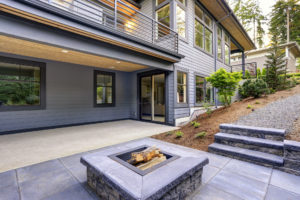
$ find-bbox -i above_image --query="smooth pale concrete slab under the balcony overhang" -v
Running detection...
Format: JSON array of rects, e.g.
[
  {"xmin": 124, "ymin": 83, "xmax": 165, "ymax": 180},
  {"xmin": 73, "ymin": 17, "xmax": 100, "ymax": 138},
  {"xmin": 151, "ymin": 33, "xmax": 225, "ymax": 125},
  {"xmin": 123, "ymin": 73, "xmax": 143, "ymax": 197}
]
[{"xmin": 0, "ymin": 120, "xmax": 176, "ymax": 173}]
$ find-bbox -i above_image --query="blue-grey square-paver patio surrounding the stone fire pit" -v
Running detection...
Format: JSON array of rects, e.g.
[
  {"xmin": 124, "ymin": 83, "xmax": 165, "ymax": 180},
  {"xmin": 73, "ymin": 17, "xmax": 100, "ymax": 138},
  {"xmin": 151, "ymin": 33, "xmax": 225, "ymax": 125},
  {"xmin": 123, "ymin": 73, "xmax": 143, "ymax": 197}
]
[{"xmin": 0, "ymin": 138, "xmax": 300, "ymax": 200}]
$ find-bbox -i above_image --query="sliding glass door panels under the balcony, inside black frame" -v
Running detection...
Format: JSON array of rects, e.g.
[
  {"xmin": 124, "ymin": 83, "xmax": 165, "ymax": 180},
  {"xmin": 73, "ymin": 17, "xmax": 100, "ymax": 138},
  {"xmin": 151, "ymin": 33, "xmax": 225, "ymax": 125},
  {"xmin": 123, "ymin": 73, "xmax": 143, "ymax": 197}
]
[{"xmin": 140, "ymin": 74, "xmax": 165, "ymax": 123}]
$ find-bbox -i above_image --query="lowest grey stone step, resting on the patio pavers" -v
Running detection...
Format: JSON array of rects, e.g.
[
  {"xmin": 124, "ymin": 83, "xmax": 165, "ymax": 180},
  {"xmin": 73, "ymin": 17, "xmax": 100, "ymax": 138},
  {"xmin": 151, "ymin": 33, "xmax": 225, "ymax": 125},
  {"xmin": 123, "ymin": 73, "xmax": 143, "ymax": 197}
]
[{"xmin": 208, "ymin": 143, "xmax": 283, "ymax": 167}]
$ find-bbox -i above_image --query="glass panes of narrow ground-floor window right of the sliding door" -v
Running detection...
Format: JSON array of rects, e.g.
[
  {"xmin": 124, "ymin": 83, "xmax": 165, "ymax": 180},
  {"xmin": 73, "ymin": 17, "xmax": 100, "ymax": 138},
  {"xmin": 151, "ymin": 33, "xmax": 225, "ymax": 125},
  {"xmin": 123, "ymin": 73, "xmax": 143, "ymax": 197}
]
[{"xmin": 177, "ymin": 71, "xmax": 187, "ymax": 103}]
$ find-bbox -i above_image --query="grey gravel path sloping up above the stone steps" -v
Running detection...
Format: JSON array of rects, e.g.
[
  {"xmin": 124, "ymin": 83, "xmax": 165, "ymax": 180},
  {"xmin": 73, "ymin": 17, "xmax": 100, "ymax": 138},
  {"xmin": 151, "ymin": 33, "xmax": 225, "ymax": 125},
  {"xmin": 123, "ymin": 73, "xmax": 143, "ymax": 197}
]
[{"xmin": 235, "ymin": 94, "xmax": 300, "ymax": 132}]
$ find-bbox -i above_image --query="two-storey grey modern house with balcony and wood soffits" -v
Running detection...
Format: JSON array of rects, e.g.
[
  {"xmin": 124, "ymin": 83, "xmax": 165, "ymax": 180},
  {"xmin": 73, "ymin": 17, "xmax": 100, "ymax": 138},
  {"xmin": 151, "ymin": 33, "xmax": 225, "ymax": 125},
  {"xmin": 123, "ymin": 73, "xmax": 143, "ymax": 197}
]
[{"xmin": 0, "ymin": 0, "xmax": 255, "ymax": 134}]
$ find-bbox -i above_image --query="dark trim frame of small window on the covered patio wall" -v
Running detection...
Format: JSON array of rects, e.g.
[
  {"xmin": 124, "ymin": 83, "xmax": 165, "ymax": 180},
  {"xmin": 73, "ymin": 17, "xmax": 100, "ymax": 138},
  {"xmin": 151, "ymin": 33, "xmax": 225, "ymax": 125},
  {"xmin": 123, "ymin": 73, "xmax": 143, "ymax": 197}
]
[{"xmin": 93, "ymin": 70, "xmax": 116, "ymax": 107}]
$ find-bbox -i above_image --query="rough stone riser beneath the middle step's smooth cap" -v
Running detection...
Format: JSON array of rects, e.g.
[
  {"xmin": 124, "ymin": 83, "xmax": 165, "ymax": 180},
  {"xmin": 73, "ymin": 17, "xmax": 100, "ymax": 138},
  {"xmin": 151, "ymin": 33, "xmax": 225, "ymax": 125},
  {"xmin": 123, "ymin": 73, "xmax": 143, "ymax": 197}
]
[{"xmin": 215, "ymin": 138, "xmax": 283, "ymax": 156}]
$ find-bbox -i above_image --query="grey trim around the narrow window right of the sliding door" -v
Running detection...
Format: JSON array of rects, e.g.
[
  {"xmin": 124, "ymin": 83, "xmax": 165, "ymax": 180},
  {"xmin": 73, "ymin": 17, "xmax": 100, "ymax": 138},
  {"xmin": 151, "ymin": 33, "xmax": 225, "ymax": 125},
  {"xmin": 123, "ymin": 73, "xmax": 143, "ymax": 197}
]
[{"xmin": 174, "ymin": 67, "xmax": 189, "ymax": 108}]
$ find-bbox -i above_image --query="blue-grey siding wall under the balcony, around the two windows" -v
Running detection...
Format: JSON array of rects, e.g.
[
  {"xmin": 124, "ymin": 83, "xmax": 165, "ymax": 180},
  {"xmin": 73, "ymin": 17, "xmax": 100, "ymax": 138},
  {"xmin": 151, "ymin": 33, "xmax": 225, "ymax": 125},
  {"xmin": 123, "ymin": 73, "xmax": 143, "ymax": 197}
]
[{"xmin": 0, "ymin": 54, "xmax": 136, "ymax": 132}]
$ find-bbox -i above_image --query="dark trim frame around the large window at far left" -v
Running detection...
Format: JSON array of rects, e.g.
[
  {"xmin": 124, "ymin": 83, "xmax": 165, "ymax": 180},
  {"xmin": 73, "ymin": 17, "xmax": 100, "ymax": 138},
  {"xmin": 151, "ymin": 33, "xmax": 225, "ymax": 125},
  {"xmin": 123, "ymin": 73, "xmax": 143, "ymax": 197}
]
[{"xmin": 0, "ymin": 56, "xmax": 46, "ymax": 112}]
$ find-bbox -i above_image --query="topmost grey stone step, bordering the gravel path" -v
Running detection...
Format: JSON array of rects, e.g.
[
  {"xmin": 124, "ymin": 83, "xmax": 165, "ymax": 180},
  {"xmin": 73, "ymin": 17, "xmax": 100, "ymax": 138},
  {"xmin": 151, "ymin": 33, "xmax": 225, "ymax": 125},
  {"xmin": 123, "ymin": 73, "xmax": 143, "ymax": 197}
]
[{"xmin": 220, "ymin": 124, "xmax": 285, "ymax": 142}]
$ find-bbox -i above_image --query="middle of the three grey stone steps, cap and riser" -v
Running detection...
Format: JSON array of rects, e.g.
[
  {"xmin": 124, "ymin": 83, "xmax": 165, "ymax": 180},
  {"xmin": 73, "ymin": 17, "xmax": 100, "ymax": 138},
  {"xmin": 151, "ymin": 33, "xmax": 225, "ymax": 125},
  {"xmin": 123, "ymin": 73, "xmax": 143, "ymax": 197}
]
[{"xmin": 215, "ymin": 133, "xmax": 284, "ymax": 156}]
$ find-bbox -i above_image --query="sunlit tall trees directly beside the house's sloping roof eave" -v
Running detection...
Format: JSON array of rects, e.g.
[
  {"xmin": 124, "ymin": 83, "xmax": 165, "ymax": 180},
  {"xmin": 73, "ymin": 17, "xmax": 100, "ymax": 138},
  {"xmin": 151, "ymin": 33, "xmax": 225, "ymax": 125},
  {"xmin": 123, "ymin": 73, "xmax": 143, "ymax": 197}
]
[{"xmin": 229, "ymin": 0, "xmax": 266, "ymax": 47}]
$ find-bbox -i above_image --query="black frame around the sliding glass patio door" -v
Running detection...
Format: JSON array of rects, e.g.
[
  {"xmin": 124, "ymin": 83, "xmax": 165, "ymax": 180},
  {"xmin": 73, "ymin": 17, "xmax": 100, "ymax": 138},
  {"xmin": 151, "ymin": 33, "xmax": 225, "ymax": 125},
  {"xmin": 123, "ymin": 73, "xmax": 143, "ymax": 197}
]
[{"xmin": 137, "ymin": 70, "xmax": 168, "ymax": 124}]
